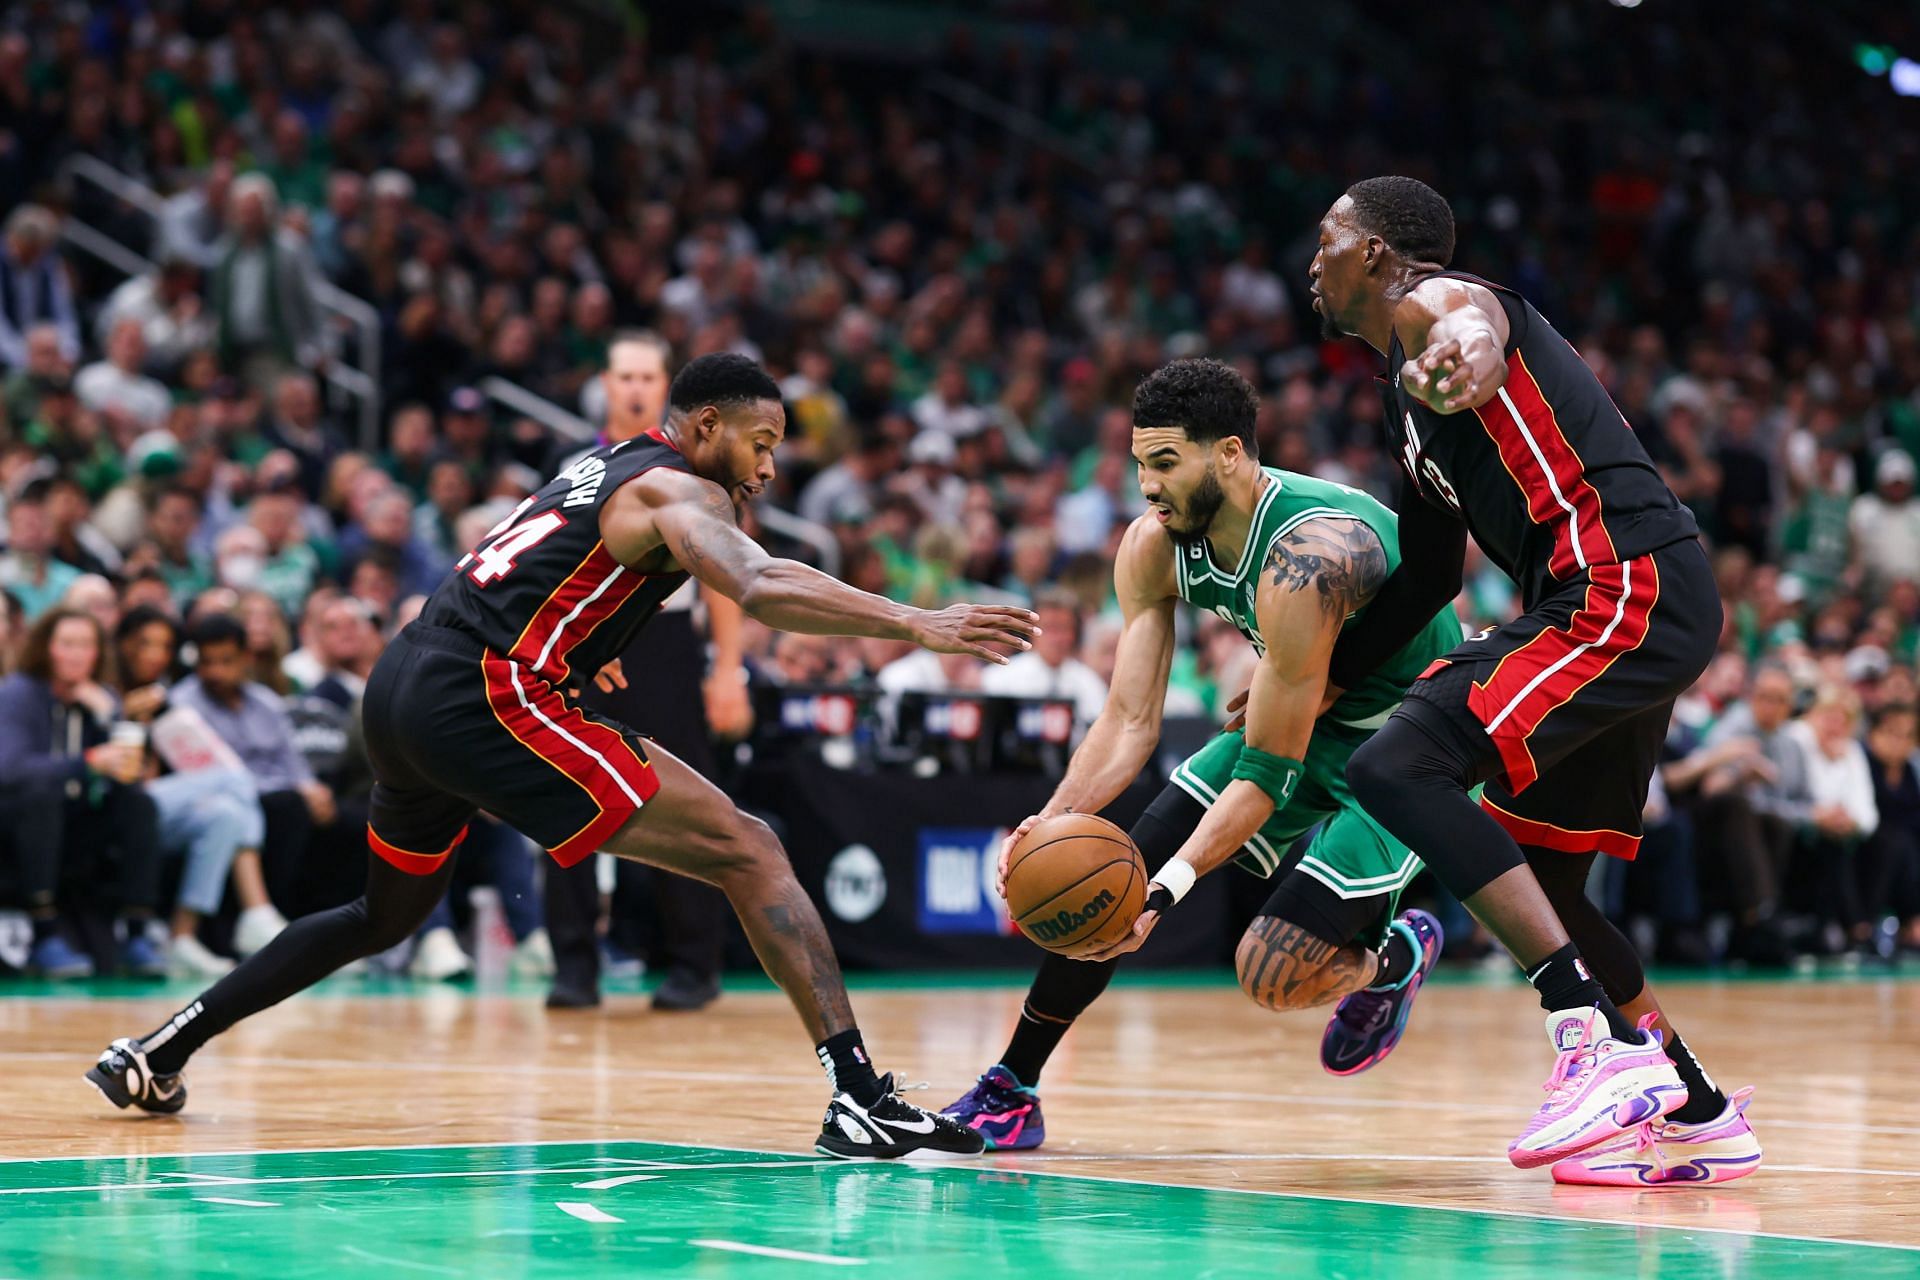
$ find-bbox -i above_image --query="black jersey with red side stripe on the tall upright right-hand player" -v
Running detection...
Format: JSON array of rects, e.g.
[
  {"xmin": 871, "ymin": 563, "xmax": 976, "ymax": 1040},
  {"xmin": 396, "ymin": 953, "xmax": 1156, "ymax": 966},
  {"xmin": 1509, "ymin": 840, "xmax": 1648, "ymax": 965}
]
[{"xmin": 1386, "ymin": 271, "xmax": 1699, "ymax": 608}]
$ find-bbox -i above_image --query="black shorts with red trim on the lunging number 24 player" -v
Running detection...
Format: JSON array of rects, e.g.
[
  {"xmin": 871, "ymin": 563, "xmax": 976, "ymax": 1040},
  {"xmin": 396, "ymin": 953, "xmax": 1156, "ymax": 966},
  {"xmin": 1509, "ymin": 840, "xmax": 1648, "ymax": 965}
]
[{"xmin": 363, "ymin": 624, "xmax": 660, "ymax": 875}]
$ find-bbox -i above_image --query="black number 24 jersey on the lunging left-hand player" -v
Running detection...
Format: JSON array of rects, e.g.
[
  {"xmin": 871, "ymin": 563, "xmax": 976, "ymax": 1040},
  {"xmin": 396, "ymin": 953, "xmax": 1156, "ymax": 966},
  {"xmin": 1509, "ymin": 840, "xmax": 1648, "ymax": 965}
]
[{"xmin": 420, "ymin": 432, "xmax": 691, "ymax": 685}]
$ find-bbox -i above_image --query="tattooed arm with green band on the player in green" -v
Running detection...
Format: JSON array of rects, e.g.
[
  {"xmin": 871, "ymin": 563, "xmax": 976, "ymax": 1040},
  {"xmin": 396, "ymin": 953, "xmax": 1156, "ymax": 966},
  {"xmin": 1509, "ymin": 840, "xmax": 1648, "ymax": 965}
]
[{"xmin": 1087, "ymin": 516, "xmax": 1386, "ymax": 960}]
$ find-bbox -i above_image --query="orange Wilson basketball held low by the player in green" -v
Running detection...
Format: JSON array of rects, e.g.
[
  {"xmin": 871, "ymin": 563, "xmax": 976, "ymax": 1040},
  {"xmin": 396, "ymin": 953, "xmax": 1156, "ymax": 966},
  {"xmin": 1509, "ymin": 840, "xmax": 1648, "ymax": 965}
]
[{"xmin": 1006, "ymin": 814, "xmax": 1146, "ymax": 956}]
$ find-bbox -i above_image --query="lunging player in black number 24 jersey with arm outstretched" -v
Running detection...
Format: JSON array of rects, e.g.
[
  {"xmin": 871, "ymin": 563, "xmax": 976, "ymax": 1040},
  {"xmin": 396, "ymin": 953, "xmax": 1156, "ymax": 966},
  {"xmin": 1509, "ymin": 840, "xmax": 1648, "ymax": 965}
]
[{"xmin": 86, "ymin": 355, "xmax": 1037, "ymax": 1157}]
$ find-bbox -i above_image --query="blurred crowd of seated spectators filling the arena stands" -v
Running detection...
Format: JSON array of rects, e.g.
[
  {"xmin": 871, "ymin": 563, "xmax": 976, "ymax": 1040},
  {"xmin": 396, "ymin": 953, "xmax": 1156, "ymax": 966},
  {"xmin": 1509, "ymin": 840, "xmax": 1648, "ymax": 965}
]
[{"xmin": 0, "ymin": 0, "xmax": 1920, "ymax": 971}]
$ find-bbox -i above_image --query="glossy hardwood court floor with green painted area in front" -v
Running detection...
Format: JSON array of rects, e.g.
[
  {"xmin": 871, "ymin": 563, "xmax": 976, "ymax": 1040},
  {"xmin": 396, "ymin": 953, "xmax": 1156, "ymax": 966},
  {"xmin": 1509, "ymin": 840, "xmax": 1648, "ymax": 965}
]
[{"xmin": 0, "ymin": 979, "xmax": 1920, "ymax": 1280}]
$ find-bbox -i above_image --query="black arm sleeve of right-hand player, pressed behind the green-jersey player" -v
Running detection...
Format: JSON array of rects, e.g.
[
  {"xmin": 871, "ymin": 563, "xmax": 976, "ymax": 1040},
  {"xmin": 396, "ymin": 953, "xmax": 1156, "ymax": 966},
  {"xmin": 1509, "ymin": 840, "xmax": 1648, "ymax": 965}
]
[{"xmin": 1327, "ymin": 474, "xmax": 1467, "ymax": 689}]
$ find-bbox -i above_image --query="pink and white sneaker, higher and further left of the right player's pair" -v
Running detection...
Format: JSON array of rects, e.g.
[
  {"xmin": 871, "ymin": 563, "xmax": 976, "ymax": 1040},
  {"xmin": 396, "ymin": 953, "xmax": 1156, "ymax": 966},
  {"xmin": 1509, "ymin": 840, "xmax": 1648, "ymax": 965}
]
[{"xmin": 1507, "ymin": 1007, "xmax": 1686, "ymax": 1169}]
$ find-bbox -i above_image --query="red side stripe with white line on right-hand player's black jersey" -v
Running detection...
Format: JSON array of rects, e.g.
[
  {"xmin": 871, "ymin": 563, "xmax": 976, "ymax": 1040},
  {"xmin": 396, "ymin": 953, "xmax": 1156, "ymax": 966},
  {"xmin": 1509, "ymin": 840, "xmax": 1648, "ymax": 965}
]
[{"xmin": 1475, "ymin": 351, "xmax": 1619, "ymax": 578}]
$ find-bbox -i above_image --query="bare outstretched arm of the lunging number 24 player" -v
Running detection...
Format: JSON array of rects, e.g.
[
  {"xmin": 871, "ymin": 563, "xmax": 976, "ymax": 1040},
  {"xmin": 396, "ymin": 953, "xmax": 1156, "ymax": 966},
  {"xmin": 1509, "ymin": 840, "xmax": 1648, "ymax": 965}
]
[{"xmin": 601, "ymin": 468, "xmax": 1037, "ymax": 662}]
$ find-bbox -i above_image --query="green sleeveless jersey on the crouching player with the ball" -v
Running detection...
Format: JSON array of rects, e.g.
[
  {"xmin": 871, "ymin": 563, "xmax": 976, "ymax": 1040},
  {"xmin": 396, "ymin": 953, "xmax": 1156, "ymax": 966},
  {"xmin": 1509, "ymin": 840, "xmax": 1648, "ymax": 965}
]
[{"xmin": 1175, "ymin": 466, "xmax": 1459, "ymax": 729}]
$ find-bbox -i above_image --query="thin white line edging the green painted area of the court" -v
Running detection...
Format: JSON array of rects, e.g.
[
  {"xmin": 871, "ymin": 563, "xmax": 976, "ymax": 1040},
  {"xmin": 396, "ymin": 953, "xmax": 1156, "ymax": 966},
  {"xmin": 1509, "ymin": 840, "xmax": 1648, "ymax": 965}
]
[{"xmin": 6, "ymin": 1138, "xmax": 1920, "ymax": 1253}]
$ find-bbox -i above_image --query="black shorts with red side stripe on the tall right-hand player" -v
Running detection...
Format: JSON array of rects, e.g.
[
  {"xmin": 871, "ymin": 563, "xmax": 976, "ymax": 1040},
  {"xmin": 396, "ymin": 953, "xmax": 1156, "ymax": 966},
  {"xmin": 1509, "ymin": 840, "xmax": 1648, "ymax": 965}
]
[{"xmin": 1407, "ymin": 539, "xmax": 1720, "ymax": 858}]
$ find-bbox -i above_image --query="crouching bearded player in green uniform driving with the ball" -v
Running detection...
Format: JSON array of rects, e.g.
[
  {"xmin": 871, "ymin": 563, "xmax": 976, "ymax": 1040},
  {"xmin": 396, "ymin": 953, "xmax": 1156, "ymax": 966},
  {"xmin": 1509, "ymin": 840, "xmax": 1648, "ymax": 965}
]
[{"xmin": 947, "ymin": 359, "xmax": 1459, "ymax": 1150}]
